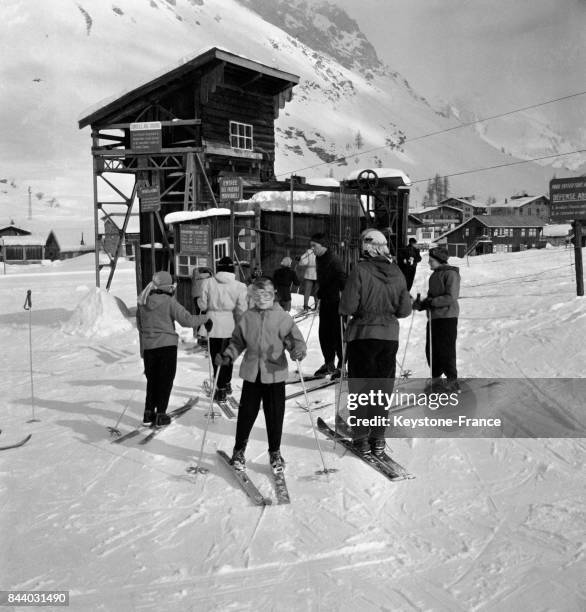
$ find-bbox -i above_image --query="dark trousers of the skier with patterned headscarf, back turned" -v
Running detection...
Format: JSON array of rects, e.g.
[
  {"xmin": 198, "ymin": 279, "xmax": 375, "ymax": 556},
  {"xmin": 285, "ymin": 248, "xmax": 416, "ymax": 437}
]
[{"xmin": 347, "ymin": 339, "xmax": 399, "ymax": 439}]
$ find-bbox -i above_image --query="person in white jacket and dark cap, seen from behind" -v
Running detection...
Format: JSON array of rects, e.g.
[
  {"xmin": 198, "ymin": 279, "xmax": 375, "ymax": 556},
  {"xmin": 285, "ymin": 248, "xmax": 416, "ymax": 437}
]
[{"xmin": 197, "ymin": 257, "xmax": 248, "ymax": 401}]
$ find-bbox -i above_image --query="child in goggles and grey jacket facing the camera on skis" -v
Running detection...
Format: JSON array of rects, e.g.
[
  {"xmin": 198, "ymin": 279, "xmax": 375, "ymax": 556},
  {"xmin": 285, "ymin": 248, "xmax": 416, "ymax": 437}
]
[{"xmin": 216, "ymin": 277, "xmax": 306, "ymax": 470}]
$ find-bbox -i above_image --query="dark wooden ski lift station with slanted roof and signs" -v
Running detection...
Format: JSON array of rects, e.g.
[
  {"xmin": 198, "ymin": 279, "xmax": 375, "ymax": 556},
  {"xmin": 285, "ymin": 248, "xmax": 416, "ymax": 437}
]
[{"xmin": 79, "ymin": 47, "xmax": 408, "ymax": 309}]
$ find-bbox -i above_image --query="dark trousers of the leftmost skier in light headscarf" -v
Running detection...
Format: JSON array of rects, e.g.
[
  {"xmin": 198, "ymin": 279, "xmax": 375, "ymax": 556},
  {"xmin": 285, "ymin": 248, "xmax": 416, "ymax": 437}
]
[{"xmin": 143, "ymin": 346, "xmax": 177, "ymax": 413}]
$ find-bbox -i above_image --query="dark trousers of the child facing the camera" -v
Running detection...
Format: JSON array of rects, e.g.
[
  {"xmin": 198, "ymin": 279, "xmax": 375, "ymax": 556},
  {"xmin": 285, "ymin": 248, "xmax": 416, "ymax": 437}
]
[{"xmin": 234, "ymin": 374, "xmax": 285, "ymax": 452}]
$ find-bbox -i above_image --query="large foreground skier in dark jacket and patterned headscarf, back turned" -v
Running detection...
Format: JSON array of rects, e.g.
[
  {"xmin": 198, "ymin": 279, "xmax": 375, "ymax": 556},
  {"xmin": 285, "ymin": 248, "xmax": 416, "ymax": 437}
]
[{"xmin": 340, "ymin": 229, "xmax": 411, "ymax": 456}]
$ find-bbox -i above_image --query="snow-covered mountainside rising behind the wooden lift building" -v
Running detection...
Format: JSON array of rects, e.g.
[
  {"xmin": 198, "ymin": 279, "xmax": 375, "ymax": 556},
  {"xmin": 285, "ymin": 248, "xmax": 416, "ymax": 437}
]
[{"xmin": 0, "ymin": 0, "xmax": 580, "ymax": 228}]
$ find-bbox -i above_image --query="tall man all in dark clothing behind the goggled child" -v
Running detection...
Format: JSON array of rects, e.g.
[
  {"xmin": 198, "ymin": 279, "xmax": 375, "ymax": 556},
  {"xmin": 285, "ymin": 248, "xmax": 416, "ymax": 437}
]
[{"xmin": 310, "ymin": 233, "xmax": 346, "ymax": 378}]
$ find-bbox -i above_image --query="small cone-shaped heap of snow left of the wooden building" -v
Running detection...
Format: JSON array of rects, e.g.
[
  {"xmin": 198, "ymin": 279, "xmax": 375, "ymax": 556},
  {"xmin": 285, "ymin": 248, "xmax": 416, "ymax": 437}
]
[{"xmin": 63, "ymin": 288, "xmax": 132, "ymax": 338}]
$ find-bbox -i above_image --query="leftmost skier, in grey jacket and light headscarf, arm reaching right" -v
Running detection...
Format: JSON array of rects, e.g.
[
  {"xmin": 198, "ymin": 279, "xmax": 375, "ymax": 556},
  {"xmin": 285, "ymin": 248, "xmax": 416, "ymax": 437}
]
[{"xmin": 136, "ymin": 270, "xmax": 213, "ymax": 426}]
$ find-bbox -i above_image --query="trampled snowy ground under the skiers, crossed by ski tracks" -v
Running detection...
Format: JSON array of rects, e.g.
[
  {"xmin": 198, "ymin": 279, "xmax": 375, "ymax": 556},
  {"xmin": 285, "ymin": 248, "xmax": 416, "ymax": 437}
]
[{"xmin": 0, "ymin": 249, "xmax": 586, "ymax": 611}]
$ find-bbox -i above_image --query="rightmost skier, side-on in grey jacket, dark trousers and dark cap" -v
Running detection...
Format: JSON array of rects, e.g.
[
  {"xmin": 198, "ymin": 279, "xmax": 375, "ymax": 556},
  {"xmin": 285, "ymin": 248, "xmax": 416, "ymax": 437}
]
[{"xmin": 413, "ymin": 247, "xmax": 460, "ymax": 391}]
